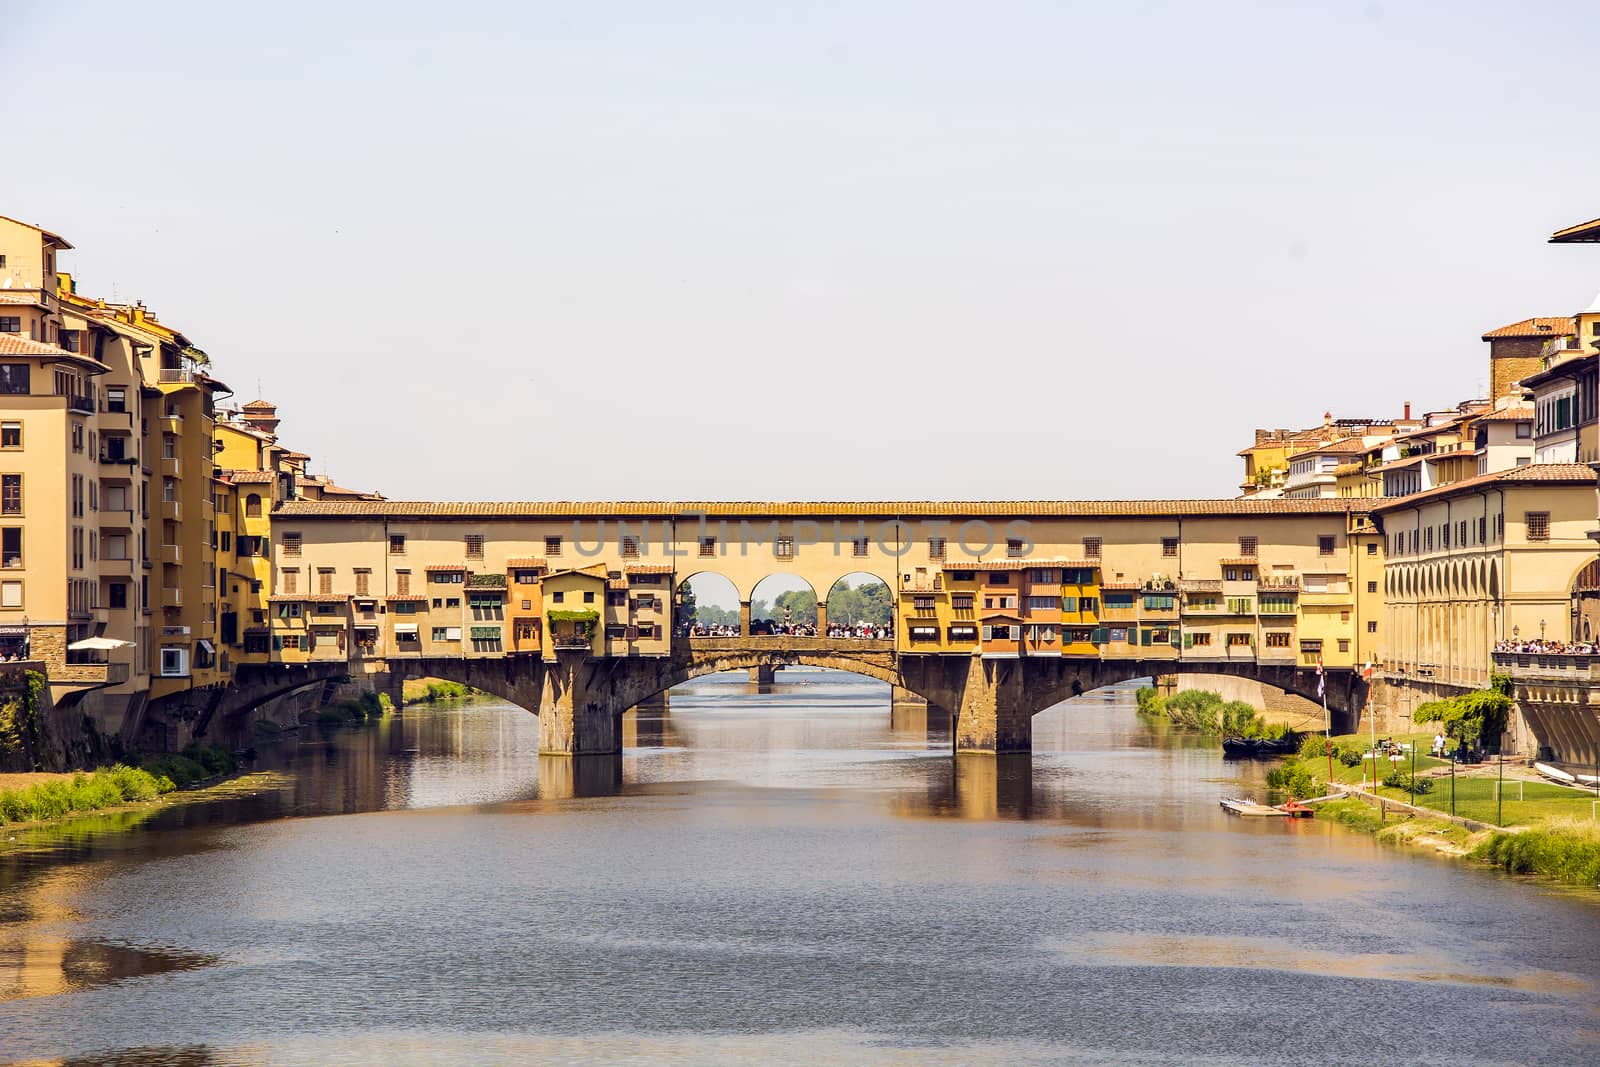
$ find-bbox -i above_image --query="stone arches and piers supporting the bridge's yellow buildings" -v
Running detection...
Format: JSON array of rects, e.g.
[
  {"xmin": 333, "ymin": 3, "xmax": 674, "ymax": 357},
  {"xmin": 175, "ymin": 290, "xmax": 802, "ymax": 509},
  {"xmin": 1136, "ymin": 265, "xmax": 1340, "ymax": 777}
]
[{"xmin": 377, "ymin": 637, "xmax": 1368, "ymax": 755}]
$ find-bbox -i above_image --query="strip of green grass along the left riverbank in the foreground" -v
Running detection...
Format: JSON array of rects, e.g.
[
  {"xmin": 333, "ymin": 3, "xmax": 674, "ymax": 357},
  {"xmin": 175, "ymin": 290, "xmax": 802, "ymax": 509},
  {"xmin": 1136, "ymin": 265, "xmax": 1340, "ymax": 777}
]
[{"xmin": 0, "ymin": 745, "xmax": 238, "ymax": 825}]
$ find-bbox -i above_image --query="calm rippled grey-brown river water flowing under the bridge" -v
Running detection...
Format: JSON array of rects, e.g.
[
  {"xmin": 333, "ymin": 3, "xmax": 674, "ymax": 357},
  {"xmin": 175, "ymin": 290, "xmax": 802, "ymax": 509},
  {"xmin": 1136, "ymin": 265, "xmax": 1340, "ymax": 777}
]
[{"xmin": 0, "ymin": 672, "xmax": 1600, "ymax": 1065}]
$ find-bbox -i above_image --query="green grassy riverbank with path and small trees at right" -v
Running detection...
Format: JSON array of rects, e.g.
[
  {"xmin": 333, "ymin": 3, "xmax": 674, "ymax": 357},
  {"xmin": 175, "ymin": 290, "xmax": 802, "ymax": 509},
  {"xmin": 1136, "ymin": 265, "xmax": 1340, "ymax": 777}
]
[{"xmin": 1269, "ymin": 734, "xmax": 1600, "ymax": 888}]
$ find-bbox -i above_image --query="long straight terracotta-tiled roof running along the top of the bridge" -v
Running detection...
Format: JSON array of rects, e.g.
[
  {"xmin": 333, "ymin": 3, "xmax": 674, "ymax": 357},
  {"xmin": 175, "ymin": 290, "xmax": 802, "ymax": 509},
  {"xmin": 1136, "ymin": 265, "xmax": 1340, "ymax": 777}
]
[{"xmin": 277, "ymin": 498, "xmax": 1368, "ymax": 523}]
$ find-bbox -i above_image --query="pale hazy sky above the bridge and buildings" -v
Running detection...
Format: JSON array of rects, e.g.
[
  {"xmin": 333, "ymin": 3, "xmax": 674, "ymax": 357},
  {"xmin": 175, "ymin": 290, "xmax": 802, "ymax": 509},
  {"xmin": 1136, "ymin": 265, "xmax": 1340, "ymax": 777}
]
[{"xmin": 0, "ymin": 0, "xmax": 1600, "ymax": 499}]
